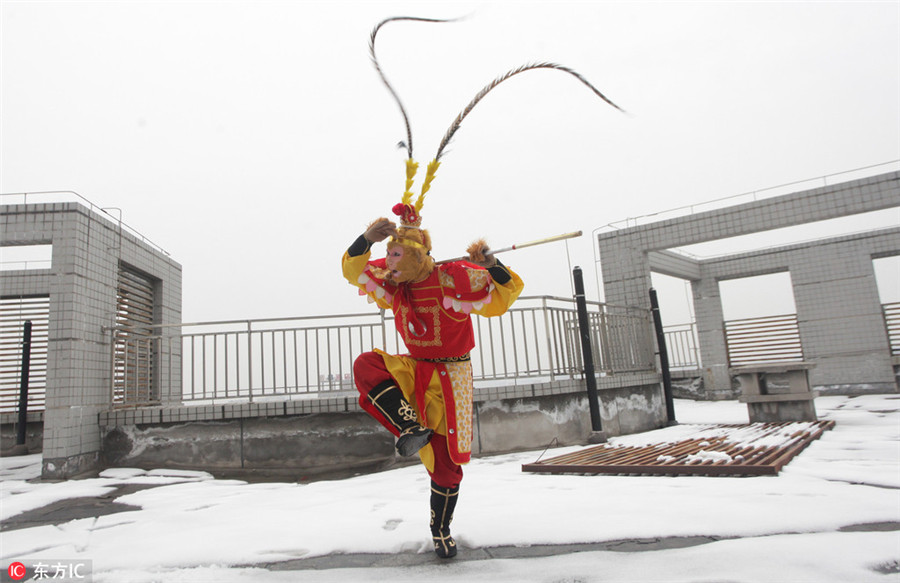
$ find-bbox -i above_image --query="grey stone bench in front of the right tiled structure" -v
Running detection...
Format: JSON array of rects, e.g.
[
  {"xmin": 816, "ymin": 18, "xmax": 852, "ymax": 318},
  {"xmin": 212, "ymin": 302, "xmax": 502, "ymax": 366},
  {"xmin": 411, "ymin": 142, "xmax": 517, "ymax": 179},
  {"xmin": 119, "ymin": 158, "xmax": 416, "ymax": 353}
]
[{"xmin": 731, "ymin": 361, "xmax": 818, "ymax": 423}]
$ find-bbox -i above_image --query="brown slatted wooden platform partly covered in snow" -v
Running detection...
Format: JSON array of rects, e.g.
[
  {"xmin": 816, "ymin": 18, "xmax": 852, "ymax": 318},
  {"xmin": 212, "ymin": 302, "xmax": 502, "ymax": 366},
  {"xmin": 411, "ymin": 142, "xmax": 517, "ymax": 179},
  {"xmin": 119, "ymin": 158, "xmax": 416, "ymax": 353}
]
[{"xmin": 522, "ymin": 421, "xmax": 834, "ymax": 476}]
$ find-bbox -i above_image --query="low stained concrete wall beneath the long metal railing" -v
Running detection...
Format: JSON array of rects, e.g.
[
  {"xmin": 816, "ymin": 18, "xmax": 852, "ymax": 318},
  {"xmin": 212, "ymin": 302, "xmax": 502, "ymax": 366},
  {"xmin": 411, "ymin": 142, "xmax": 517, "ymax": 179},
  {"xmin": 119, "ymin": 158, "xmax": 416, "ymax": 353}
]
[{"xmin": 101, "ymin": 373, "xmax": 667, "ymax": 479}]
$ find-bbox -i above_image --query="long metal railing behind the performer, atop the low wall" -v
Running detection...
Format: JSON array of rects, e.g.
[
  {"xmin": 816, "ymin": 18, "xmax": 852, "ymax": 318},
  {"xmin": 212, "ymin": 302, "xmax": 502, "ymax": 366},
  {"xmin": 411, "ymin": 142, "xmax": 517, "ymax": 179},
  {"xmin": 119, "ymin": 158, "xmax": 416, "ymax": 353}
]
[{"xmin": 110, "ymin": 296, "xmax": 655, "ymax": 406}]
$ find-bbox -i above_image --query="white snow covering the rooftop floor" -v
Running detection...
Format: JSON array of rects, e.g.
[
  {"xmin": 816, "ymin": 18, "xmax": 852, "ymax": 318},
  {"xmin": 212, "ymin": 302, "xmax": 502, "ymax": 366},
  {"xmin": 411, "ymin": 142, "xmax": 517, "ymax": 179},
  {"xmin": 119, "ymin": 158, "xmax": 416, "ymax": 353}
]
[{"xmin": 0, "ymin": 395, "xmax": 900, "ymax": 583}]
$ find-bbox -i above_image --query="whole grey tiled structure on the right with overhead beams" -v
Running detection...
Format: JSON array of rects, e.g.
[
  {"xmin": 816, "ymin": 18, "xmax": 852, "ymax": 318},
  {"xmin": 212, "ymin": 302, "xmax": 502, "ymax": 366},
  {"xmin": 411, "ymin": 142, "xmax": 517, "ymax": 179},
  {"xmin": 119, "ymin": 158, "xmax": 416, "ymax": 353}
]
[{"xmin": 598, "ymin": 172, "xmax": 900, "ymax": 398}]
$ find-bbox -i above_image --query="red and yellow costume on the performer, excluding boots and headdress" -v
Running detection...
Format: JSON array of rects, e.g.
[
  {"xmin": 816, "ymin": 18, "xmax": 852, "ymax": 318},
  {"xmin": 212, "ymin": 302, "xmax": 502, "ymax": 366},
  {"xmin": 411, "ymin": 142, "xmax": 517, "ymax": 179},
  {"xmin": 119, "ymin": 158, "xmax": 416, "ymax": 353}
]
[{"xmin": 342, "ymin": 248, "xmax": 524, "ymax": 487}]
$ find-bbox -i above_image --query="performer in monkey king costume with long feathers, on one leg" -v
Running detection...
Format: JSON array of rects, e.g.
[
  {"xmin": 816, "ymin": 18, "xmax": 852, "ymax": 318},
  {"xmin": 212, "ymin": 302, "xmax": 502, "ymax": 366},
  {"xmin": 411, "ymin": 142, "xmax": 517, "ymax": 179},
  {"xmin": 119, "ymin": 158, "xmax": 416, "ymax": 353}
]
[{"xmin": 342, "ymin": 17, "xmax": 618, "ymax": 558}]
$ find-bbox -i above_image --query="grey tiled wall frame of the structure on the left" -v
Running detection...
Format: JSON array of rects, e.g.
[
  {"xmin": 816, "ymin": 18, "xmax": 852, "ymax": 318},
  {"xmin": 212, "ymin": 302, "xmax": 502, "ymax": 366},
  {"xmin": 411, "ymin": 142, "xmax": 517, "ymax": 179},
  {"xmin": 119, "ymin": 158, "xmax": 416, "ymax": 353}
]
[{"xmin": 0, "ymin": 203, "xmax": 181, "ymax": 478}]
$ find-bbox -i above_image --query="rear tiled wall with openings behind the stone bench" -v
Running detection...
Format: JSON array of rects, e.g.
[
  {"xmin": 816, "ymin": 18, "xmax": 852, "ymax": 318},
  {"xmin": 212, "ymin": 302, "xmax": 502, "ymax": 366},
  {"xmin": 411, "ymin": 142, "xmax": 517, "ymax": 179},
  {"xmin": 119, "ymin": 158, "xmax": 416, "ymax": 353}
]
[{"xmin": 693, "ymin": 227, "xmax": 900, "ymax": 392}]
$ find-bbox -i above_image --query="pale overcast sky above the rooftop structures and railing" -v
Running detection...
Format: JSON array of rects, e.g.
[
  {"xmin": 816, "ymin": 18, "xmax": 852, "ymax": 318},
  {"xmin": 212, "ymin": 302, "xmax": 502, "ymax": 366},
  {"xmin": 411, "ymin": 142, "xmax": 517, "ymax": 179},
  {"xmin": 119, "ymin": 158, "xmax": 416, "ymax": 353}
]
[{"xmin": 0, "ymin": 0, "xmax": 900, "ymax": 321}]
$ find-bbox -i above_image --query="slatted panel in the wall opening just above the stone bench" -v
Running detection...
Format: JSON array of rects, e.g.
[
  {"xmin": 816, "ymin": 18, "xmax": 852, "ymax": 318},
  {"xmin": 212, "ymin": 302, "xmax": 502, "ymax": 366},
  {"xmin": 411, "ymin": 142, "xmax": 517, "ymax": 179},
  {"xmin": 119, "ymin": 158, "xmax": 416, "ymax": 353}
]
[{"xmin": 725, "ymin": 314, "xmax": 803, "ymax": 366}]
